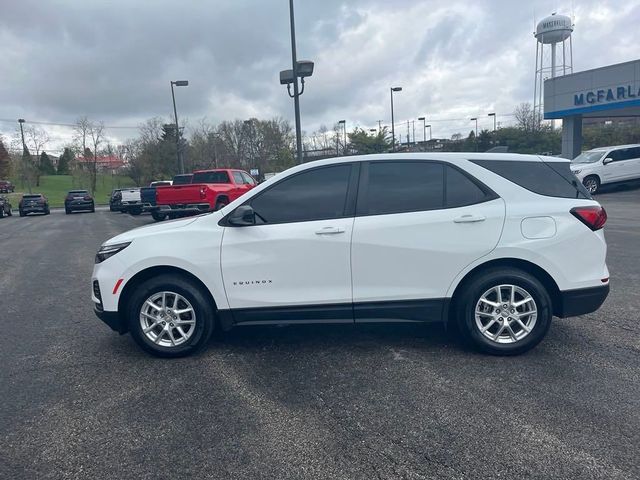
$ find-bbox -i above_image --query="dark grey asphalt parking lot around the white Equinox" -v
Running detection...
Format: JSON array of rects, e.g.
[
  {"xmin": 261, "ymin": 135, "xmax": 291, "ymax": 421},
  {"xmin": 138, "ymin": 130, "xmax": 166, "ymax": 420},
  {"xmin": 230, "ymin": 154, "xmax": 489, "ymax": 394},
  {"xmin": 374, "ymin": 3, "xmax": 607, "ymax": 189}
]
[{"xmin": 0, "ymin": 186, "xmax": 640, "ymax": 480}]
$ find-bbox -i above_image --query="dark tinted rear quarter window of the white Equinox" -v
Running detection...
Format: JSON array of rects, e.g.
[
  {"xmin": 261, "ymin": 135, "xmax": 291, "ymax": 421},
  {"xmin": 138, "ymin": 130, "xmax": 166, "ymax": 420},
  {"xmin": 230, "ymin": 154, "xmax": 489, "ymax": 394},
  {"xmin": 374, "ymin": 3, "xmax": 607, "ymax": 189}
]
[{"xmin": 471, "ymin": 160, "xmax": 591, "ymax": 199}]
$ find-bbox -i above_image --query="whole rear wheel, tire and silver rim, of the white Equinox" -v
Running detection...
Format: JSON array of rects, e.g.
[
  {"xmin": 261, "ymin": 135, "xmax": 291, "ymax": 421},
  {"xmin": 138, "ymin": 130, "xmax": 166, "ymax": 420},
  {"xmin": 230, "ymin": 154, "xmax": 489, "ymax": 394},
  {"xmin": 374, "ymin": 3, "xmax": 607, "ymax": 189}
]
[{"xmin": 458, "ymin": 268, "xmax": 552, "ymax": 355}]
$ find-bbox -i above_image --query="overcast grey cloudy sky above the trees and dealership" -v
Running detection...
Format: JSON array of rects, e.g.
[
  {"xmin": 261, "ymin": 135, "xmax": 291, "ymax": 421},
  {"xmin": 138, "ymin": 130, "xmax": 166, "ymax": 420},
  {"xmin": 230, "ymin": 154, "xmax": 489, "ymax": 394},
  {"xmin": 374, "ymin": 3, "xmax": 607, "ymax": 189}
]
[{"xmin": 0, "ymin": 0, "xmax": 640, "ymax": 150}]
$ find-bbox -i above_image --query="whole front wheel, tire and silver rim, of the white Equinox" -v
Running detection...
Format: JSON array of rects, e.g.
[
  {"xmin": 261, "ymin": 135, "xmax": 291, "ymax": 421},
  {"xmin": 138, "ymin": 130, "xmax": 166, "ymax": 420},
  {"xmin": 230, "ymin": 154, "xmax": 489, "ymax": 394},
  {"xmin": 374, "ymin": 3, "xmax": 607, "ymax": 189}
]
[{"xmin": 127, "ymin": 275, "xmax": 215, "ymax": 357}]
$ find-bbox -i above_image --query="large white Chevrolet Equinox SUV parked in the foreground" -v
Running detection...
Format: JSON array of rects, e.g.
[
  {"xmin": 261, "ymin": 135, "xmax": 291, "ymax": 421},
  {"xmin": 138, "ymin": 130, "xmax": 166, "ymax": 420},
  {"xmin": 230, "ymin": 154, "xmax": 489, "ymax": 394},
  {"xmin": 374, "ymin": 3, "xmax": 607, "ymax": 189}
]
[{"xmin": 92, "ymin": 153, "xmax": 609, "ymax": 357}]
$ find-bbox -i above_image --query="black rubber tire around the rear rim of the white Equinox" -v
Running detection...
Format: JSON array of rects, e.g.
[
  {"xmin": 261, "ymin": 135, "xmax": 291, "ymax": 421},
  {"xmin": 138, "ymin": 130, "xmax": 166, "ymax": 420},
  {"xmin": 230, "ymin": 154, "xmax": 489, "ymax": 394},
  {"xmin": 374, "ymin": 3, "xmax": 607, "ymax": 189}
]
[{"xmin": 456, "ymin": 268, "xmax": 553, "ymax": 355}]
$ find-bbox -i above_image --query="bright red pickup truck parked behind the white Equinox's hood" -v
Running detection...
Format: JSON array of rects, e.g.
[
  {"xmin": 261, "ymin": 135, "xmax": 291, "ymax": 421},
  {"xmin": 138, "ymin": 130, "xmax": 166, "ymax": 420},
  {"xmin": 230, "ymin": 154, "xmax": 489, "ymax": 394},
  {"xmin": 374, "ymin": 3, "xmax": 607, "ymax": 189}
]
[{"xmin": 151, "ymin": 168, "xmax": 257, "ymax": 221}]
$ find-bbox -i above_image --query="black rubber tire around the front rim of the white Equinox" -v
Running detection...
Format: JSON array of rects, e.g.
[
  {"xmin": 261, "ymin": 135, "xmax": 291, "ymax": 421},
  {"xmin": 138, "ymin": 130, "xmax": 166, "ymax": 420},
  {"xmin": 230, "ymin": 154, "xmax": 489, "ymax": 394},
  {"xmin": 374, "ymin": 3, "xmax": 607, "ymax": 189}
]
[{"xmin": 126, "ymin": 274, "xmax": 215, "ymax": 358}]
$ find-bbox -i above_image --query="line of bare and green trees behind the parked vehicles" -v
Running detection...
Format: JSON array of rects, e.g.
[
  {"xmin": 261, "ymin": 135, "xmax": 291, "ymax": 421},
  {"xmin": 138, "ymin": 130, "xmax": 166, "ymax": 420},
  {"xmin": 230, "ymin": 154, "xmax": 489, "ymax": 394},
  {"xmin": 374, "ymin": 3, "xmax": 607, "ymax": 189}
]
[{"xmin": 0, "ymin": 103, "xmax": 640, "ymax": 192}]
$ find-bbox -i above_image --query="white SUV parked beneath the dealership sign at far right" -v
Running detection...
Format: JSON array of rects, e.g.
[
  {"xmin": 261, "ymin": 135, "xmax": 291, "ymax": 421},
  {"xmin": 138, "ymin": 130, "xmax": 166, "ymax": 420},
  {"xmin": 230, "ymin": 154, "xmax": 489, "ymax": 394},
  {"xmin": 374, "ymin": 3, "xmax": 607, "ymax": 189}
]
[{"xmin": 571, "ymin": 145, "xmax": 640, "ymax": 194}]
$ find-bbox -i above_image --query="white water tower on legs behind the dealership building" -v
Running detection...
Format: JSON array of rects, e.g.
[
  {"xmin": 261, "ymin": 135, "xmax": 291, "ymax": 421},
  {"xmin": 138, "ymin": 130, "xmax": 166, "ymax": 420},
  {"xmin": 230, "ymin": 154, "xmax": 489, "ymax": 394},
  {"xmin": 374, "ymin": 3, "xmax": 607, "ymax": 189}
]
[{"xmin": 533, "ymin": 13, "xmax": 573, "ymax": 120}]
